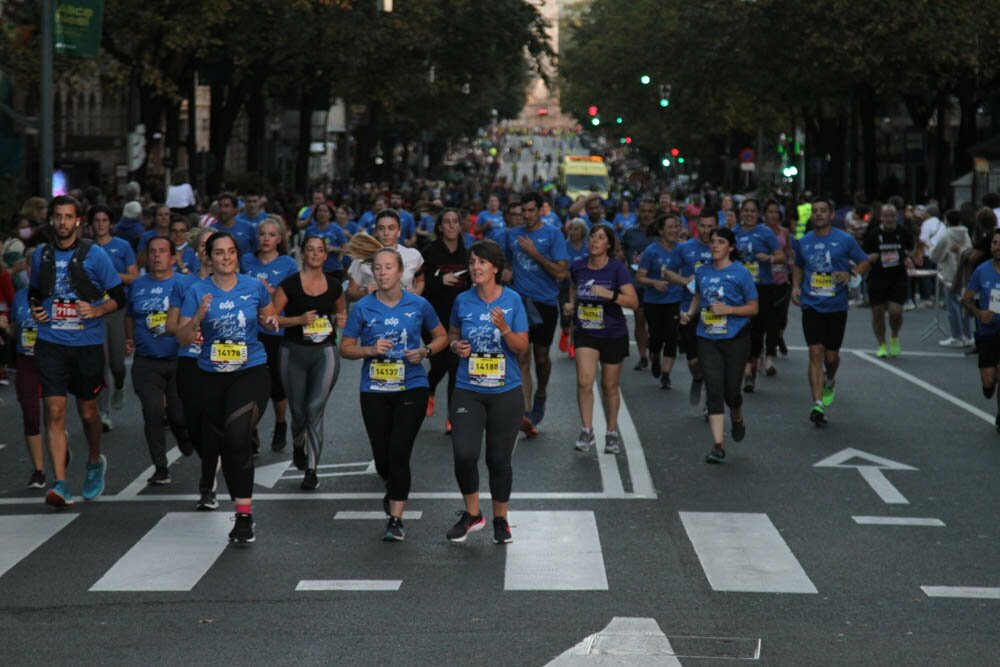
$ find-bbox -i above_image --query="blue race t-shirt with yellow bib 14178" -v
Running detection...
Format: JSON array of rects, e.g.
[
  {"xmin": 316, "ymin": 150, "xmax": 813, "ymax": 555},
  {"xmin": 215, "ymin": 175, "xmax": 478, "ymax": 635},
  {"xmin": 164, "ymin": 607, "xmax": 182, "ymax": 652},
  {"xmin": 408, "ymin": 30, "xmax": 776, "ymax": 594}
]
[{"xmin": 181, "ymin": 275, "xmax": 271, "ymax": 373}]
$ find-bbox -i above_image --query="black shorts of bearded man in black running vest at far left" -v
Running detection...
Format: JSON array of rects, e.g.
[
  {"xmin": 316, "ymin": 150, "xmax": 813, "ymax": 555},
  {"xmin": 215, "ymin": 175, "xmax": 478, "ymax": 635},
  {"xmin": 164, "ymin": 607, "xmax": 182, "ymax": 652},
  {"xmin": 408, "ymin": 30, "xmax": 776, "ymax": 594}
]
[{"xmin": 35, "ymin": 340, "xmax": 104, "ymax": 401}]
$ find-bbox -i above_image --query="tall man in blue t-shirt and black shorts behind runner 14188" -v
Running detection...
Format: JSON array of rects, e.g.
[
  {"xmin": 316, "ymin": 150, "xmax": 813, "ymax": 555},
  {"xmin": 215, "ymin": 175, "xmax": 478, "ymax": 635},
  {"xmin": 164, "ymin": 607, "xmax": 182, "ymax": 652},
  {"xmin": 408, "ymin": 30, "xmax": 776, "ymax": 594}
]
[{"xmin": 506, "ymin": 192, "xmax": 569, "ymax": 438}]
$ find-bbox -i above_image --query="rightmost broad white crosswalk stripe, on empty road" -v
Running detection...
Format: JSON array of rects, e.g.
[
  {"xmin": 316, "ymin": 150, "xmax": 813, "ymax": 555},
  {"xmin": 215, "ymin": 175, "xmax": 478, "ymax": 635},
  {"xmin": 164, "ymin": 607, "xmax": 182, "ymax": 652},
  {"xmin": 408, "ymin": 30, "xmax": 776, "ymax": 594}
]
[{"xmin": 680, "ymin": 512, "xmax": 817, "ymax": 593}]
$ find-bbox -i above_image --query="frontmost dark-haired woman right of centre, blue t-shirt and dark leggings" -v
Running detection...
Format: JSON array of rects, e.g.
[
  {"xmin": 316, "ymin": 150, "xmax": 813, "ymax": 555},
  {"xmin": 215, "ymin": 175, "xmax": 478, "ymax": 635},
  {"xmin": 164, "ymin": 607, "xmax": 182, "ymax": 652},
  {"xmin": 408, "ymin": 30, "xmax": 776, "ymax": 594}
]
[{"xmin": 681, "ymin": 228, "xmax": 757, "ymax": 463}]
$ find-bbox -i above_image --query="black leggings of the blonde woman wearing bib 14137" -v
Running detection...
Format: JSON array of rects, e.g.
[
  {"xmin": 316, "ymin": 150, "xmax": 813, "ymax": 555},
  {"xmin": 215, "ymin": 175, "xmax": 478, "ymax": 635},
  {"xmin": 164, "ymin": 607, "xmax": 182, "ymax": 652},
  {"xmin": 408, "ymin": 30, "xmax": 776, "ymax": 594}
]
[{"xmin": 361, "ymin": 387, "xmax": 427, "ymax": 501}]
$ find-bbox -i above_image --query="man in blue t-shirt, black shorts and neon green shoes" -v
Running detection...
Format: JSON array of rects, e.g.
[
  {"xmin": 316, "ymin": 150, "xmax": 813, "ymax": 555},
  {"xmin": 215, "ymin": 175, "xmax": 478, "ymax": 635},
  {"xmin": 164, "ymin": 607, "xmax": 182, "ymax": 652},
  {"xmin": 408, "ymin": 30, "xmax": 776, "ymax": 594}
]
[{"xmin": 792, "ymin": 198, "xmax": 871, "ymax": 427}]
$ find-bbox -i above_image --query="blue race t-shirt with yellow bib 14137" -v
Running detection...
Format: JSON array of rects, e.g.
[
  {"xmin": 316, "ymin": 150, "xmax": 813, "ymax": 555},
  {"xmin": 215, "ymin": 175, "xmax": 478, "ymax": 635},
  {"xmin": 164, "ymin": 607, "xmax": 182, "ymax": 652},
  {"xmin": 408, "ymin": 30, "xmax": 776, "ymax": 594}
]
[{"xmin": 343, "ymin": 290, "xmax": 441, "ymax": 393}]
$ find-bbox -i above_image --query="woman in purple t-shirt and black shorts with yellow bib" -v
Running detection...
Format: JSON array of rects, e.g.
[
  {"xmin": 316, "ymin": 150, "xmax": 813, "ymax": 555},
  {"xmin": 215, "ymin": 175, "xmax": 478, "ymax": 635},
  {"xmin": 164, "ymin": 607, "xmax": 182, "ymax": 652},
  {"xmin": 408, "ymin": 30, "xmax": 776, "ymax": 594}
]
[{"xmin": 563, "ymin": 224, "xmax": 639, "ymax": 454}]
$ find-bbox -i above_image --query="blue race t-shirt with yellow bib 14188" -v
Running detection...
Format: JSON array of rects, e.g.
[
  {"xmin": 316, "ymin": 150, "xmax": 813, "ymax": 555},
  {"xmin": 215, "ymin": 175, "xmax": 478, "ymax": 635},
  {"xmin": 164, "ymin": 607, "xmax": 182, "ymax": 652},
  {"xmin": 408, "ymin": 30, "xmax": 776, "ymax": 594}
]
[{"xmin": 451, "ymin": 287, "xmax": 528, "ymax": 394}]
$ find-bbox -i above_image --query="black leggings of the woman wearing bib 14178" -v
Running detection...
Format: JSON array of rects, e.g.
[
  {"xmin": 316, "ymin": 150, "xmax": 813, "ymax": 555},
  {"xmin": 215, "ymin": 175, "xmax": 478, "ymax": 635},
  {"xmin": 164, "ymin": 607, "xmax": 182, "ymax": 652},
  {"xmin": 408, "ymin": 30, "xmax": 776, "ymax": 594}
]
[{"xmin": 199, "ymin": 366, "xmax": 271, "ymax": 498}]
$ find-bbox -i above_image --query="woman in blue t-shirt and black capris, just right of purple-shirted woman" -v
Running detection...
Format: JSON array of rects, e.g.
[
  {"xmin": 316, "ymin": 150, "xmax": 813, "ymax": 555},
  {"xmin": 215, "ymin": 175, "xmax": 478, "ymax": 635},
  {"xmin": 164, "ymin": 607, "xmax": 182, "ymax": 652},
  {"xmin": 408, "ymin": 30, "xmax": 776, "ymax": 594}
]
[{"xmin": 635, "ymin": 213, "xmax": 685, "ymax": 389}]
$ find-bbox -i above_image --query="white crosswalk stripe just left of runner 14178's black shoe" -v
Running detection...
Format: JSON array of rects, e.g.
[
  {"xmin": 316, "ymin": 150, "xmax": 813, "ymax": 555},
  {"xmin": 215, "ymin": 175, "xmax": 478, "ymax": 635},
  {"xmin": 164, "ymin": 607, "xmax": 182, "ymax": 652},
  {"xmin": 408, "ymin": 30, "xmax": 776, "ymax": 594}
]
[{"xmin": 90, "ymin": 512, "xmax": 233, "ymax": 591}]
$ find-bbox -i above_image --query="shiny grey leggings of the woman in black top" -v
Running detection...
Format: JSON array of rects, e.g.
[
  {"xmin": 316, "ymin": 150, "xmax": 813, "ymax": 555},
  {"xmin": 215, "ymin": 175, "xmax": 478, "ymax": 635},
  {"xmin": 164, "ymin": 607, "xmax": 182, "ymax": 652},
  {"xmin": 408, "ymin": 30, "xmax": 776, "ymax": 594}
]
[{"xmin": 281, "ymin": 341, "xmax": 340, "ymax": 470}]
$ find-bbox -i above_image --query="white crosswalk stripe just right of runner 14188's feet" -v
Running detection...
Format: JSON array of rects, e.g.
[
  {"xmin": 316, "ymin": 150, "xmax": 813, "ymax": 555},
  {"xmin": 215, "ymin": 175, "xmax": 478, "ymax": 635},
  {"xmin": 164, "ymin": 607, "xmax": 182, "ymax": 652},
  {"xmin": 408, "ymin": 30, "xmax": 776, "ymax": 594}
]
[{"xmin": 504, "ymin": 511, "xmax": 608, "ymax": 591}]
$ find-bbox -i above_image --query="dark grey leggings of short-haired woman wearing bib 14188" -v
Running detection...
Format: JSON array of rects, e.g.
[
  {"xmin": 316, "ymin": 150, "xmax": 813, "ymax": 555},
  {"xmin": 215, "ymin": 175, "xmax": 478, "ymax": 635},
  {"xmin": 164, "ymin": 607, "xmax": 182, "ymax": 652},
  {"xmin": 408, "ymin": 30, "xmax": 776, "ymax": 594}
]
[{"xmin": 450, "ymin": 386, "xmax": 524, "ymax": 503}]
